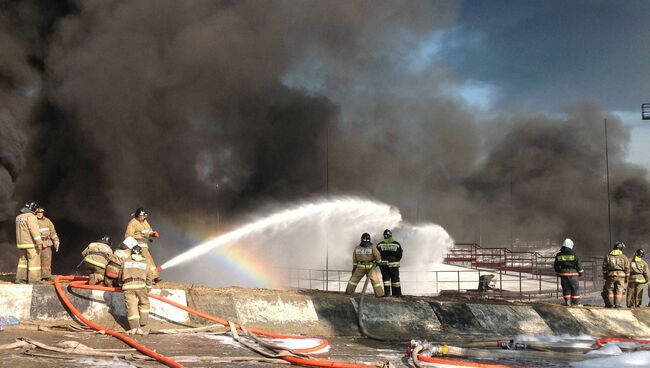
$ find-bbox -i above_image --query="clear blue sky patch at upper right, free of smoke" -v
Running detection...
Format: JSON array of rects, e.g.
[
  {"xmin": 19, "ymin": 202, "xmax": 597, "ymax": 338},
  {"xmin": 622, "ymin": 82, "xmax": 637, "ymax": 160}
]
[{"xmin": 440, "ymin": 0, "xmax": 650, "ymax": 169}]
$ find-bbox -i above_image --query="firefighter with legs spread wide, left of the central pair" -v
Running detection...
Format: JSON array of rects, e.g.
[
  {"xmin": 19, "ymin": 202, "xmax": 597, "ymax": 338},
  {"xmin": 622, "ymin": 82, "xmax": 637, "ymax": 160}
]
[{"xmin": 345, "ymin": 233, "xmax": 384, "ymax": 297}]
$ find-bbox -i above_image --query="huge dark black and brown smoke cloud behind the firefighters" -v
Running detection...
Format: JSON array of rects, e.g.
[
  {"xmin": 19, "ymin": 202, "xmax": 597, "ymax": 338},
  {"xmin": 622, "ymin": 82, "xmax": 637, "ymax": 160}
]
[{"xmin": 0, "ymin": 0, "xmax": 650, "ymax": 272}]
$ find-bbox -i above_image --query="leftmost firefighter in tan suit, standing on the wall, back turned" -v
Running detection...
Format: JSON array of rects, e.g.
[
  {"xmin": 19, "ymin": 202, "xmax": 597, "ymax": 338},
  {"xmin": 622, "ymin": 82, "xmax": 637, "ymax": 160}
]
[{"xmin": 14, "ymin": 201, "xmax": 43, "ymax": 284}]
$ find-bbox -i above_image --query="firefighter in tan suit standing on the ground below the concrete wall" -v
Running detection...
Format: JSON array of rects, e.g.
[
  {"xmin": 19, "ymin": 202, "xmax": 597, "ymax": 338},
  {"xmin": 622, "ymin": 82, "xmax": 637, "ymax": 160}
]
[{"xmin": 120, "ymin": 245, "xmax": 153, "ymax": 335}]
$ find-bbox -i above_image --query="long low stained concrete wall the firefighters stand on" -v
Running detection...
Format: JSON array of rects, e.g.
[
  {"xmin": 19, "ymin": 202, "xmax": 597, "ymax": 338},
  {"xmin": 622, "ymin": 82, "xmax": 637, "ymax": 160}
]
[{"xmin": 0, "ymin": 284, "xmax": 650, "ymax": 339}]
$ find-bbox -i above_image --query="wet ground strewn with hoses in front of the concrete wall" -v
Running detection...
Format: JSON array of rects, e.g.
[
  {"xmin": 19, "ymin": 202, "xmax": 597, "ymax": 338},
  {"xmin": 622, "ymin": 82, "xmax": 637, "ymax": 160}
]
[{"xmin": 0, "ymin": 326, "xmax": 584, "ymax": 368}]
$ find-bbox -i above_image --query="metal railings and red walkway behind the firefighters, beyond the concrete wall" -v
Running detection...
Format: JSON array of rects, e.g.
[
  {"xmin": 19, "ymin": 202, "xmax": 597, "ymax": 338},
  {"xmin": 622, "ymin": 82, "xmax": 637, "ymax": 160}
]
[{"xmin": 276, "ymin": 244, "xmax": 602, "ymax": 300}]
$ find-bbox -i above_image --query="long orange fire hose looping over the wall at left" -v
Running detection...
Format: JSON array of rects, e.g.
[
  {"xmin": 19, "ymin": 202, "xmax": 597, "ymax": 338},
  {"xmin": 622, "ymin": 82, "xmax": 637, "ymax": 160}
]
[{"xmin": 54, "ymin": 276, "xmax": 384, "ymax": 368}]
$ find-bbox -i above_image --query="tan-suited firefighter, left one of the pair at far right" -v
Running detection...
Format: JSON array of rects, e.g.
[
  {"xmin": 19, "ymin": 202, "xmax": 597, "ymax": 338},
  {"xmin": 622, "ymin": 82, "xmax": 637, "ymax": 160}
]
[{"xmin": 601, "ymin": 242, "xmax": 630, "ymax": 308}]
